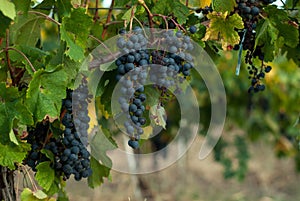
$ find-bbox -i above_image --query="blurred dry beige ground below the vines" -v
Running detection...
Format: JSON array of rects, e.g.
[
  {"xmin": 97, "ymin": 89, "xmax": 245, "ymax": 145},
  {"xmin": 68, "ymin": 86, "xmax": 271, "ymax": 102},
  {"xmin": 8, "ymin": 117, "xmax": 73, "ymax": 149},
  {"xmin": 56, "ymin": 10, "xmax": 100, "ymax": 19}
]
[{"xmin": 67, "ymin": 137, "xmax": 300, "ymax": 201}]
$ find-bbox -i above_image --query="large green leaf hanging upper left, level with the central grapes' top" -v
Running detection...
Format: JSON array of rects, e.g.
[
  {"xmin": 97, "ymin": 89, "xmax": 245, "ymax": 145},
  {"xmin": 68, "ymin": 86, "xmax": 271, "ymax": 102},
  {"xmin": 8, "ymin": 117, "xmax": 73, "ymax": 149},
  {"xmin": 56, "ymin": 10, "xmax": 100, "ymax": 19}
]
[{"xmin": 60, "ymin": 9, "xmax": 93, "ymax": 61}]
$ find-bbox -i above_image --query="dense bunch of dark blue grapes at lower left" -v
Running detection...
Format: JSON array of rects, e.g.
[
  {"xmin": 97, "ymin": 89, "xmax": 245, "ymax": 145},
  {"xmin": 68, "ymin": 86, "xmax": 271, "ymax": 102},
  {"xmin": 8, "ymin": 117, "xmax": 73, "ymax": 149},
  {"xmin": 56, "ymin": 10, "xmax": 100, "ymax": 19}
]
[{"xmin": 24, "ymin": 80, "xmax": 92, "ymax": 181}]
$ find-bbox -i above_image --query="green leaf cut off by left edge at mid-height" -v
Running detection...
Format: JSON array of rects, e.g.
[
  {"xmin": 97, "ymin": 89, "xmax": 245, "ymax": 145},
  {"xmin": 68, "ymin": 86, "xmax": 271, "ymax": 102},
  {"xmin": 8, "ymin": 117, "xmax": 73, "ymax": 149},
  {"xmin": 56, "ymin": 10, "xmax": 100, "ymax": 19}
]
[{"xmin": 0, "ymin": 83, "xmax": 34, "ymax": 143}]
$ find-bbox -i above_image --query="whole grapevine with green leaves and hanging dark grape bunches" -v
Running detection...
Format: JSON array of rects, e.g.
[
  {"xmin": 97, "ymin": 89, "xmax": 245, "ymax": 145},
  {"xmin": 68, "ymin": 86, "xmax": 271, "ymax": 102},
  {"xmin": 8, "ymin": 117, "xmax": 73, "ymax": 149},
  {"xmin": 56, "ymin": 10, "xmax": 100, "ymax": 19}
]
[{"xmin": 0, "ymin": 0, "xmax": 300, "ymax": 201}]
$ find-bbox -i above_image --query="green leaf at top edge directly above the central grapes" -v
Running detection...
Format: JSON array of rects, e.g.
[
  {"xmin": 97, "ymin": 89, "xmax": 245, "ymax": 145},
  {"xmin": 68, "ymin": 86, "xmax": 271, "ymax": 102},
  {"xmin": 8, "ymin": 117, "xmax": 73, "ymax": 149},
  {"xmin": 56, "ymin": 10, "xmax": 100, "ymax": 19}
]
[{"xmin": 151, "ymin": 0, "xmax": 190, "ymax": 24}]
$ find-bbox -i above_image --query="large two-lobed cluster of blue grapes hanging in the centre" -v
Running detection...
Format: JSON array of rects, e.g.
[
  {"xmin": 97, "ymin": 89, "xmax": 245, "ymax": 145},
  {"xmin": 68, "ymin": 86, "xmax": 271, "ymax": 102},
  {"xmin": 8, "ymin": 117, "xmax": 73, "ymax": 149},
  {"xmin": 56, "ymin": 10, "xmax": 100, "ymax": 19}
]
[{"xmin": 115, "ymin": 27, "xmax": 197, "ymax": 149}]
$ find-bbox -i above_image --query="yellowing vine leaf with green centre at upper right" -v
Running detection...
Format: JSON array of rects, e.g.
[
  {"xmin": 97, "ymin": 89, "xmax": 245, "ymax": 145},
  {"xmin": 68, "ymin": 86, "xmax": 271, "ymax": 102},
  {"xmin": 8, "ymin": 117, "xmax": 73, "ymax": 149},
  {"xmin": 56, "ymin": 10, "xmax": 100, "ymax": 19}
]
[{"xmin": 203, "ymin": 11, "xmax": 244, "ymax": 50}]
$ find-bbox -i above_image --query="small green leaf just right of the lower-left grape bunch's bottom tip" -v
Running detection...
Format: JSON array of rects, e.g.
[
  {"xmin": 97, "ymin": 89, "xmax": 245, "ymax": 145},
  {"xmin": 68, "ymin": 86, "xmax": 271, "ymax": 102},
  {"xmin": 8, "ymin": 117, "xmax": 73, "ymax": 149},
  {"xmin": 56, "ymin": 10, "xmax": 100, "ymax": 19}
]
[{"xmin": 88, "ymin": 157, "xmax": 110, "ymax": 188}]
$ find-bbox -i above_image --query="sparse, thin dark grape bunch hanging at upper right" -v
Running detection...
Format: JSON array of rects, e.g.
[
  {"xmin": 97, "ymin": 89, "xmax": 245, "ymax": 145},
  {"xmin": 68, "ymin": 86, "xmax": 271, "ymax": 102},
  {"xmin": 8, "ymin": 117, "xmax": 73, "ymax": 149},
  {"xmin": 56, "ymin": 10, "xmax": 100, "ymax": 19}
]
[{"xmin": 235, "ymin": 0, "xmax": 275, "ymax": 93}]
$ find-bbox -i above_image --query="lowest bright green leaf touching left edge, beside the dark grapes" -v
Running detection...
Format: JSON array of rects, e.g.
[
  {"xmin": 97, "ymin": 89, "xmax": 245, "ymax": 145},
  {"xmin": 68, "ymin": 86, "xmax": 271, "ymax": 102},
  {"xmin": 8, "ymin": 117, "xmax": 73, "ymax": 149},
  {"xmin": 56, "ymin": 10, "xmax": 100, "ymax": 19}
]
[{"xmin": 0, "ymin": 143, "xmax": 30, "ymax": 170}]
